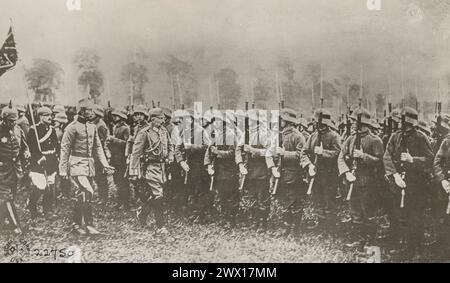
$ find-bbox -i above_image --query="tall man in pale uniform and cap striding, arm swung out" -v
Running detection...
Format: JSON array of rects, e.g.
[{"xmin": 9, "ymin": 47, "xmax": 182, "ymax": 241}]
[{"xmin": 59, "ymin": 98, "xmax": 114, "ymax": 235}]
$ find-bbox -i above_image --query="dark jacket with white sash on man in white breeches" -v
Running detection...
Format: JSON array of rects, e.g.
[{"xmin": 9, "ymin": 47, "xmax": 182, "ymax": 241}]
[{"xmin": 27, "ymin": 123, "xmax": 60, "ymax": 174}]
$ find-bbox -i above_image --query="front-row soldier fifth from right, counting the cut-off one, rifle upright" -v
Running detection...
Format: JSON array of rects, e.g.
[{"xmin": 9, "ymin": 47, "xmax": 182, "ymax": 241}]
[{"xmin": 266, "ymin": 108, "xmax": 307, "ymax": 235}]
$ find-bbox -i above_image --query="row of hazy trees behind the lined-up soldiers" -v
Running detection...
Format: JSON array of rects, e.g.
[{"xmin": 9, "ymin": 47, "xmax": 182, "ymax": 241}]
[{"xmin": 25, "ymin": 48, "xmax": 450, "ymax": 120}]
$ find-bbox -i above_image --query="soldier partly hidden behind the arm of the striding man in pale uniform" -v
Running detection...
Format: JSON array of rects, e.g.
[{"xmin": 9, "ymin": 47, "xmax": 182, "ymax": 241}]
[{"xmin": 89, "ymin": 105, "xmax": 109, "ymax": 204}]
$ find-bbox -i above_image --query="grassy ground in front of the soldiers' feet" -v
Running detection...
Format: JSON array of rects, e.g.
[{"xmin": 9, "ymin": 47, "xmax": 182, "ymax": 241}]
[{"xmin": 0, "ymin": 191, "xmax": 443, "ymax": 263}]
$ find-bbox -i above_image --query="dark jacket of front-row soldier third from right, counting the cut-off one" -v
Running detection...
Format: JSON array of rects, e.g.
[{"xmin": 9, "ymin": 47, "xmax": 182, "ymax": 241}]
[{"xmin": 338, "ymin": 131, "xmax": 384, "ymax": 186}]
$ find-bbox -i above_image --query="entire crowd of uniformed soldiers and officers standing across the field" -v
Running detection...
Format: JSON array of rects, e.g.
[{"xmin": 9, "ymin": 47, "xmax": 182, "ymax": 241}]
[{"xmin": 0, "ymin": 99, "xmax": 450, "ymax": 262}]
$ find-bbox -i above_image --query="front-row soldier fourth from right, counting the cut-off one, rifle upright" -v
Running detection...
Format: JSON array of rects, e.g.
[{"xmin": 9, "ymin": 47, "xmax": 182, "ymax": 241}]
[{"xmin": 301, "ymin": 110, "xmax": 341, "ymax": 231}]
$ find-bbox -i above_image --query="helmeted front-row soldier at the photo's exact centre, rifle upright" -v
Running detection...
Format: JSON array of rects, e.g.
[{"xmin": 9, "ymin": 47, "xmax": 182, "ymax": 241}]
[{"xmin": 204, "ymin": 111, "xmax": 243, "ymax": 227}]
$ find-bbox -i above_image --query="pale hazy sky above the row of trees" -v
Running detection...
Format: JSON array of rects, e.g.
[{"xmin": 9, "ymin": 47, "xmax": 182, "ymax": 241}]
[{"xmin": 0, "ymin": 0, "xmax": 450, "ymax": 106}]
